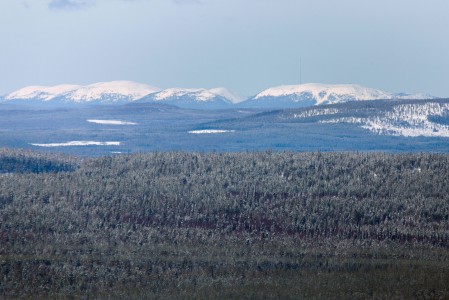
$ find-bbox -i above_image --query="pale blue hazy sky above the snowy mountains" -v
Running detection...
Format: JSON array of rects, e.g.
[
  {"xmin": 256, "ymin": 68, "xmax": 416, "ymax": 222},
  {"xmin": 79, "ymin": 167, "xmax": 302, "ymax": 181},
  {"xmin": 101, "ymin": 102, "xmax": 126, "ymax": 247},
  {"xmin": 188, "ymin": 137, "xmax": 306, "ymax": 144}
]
[{"xmin": 0, "ymin": 0, "xmax": 449, "ymax": 97}]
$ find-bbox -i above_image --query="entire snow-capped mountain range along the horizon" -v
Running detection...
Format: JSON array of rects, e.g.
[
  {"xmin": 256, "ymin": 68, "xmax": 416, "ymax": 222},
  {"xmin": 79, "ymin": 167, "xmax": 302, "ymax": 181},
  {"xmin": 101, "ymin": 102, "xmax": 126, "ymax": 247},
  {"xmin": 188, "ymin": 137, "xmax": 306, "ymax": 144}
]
[{"xmin": 0, "ymin": 81, "xmax": 436, "ymax": 109}]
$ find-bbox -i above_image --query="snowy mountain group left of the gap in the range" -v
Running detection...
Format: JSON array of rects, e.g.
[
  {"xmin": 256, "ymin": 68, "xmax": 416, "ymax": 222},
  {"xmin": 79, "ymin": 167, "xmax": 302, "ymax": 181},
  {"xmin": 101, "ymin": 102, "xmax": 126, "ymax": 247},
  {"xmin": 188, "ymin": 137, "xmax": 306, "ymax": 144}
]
[{"xmin": 4, "ymin": 81, "xmax": 238, "ymax": 108}]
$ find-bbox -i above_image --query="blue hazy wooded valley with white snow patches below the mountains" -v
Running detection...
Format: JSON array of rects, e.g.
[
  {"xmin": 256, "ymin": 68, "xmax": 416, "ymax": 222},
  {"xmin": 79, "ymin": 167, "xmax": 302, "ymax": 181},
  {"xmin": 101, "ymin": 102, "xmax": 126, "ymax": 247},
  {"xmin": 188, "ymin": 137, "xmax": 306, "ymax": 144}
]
[{"xmin": 0, "ymin": 99, "xmax": 449, "ymax": 156}]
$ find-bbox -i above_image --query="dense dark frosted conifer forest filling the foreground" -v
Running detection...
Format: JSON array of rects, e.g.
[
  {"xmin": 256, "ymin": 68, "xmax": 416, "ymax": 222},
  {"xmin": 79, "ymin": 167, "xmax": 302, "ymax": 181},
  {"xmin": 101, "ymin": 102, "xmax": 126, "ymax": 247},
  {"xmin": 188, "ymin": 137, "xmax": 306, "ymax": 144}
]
[{"xmin": 0, "ymin": 149, "xmax": 449, "ymax": 299}]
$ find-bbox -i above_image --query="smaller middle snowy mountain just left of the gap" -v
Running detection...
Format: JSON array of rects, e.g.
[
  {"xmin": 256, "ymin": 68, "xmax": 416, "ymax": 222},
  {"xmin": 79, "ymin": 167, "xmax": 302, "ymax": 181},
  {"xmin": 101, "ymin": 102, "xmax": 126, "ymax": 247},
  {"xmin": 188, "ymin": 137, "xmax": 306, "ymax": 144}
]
[{"xmin": 139, "ymin": 88, "xmax": 241, "ymax": 109}]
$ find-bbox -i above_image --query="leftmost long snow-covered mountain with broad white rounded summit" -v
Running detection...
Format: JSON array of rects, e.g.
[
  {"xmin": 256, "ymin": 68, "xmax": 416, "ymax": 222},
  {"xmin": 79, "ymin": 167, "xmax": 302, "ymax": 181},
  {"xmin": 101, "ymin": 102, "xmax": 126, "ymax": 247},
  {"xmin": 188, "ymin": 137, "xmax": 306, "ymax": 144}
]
[{"xmin": 4, "ymin": 81, "xmax": 160, "ymax": 104}]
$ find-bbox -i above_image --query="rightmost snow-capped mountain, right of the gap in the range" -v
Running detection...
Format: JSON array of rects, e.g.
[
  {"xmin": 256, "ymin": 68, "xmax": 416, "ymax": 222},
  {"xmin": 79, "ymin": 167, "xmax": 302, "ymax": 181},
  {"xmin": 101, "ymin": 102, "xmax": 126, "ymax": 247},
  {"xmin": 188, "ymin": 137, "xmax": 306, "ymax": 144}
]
[{"xmin": 241, "ymin": 83, "xmax": 435, "ymax": 108}]
